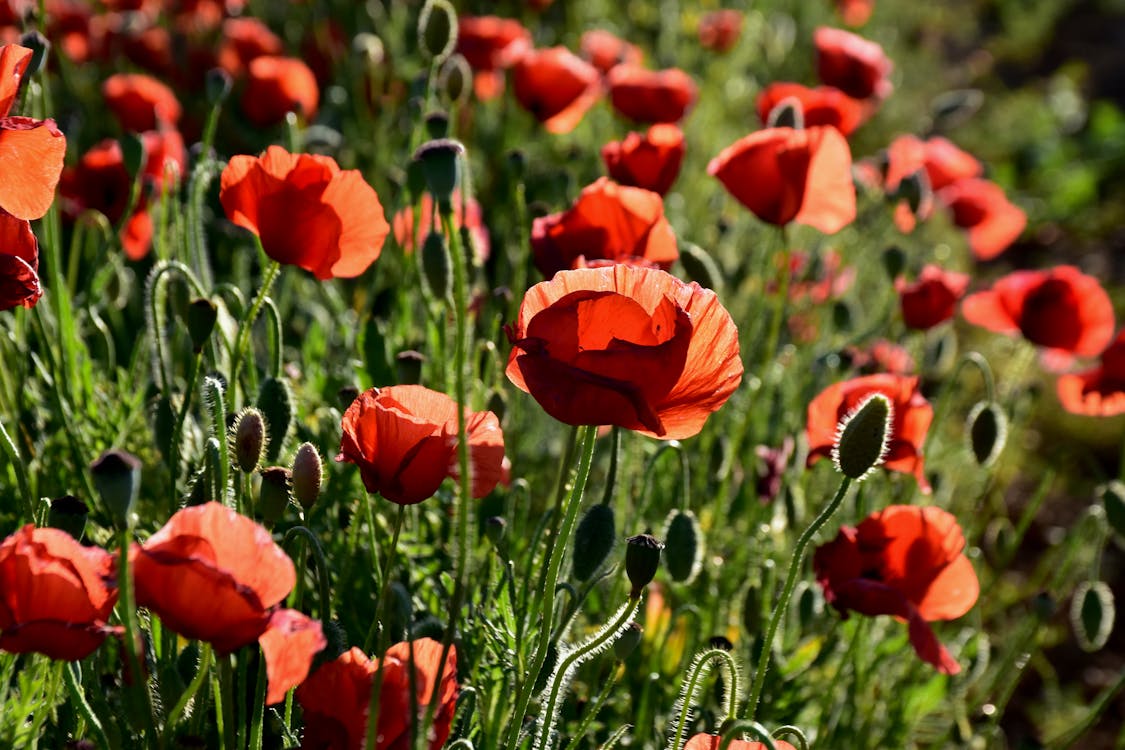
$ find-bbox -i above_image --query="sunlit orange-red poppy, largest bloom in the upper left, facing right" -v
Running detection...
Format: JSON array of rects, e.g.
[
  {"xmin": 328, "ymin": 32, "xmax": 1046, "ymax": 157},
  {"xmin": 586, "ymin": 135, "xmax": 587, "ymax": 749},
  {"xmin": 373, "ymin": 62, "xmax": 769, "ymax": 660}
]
[{"xmin": 219, "ymin": 146, "xmax": 390, "ymax": 279}]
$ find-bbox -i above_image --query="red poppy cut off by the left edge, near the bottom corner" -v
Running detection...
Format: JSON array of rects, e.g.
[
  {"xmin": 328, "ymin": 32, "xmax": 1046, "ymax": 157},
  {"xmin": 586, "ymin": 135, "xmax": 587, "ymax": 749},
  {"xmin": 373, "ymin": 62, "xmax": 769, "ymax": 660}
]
[{"xmin": 0, "ymin": 524, "xmax": 117, "ymax": 661}]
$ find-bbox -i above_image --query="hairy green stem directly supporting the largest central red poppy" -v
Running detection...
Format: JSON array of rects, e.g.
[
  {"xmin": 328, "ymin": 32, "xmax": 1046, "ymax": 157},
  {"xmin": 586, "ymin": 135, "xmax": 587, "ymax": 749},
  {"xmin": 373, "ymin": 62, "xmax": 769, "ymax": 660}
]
[{"xmin": 505, "ymin": 426, "xmax": 597, "ymax": 750}]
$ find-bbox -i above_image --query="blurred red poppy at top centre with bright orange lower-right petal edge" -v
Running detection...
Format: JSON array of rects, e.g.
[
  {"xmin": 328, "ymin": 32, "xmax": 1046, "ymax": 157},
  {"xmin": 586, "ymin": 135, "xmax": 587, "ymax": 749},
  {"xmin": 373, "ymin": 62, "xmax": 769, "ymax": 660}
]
[{"xmin": 512, "ymin": 47, "xmax": 601, "ymax": 133}]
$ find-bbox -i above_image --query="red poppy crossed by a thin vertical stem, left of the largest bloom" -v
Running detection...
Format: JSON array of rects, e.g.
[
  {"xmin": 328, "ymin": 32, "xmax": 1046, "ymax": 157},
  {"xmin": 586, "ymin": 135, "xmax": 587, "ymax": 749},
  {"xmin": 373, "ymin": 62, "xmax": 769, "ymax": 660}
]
[{"xmin": 336, "ymin": 386, "xmax": 504, "ymax": 505}]
